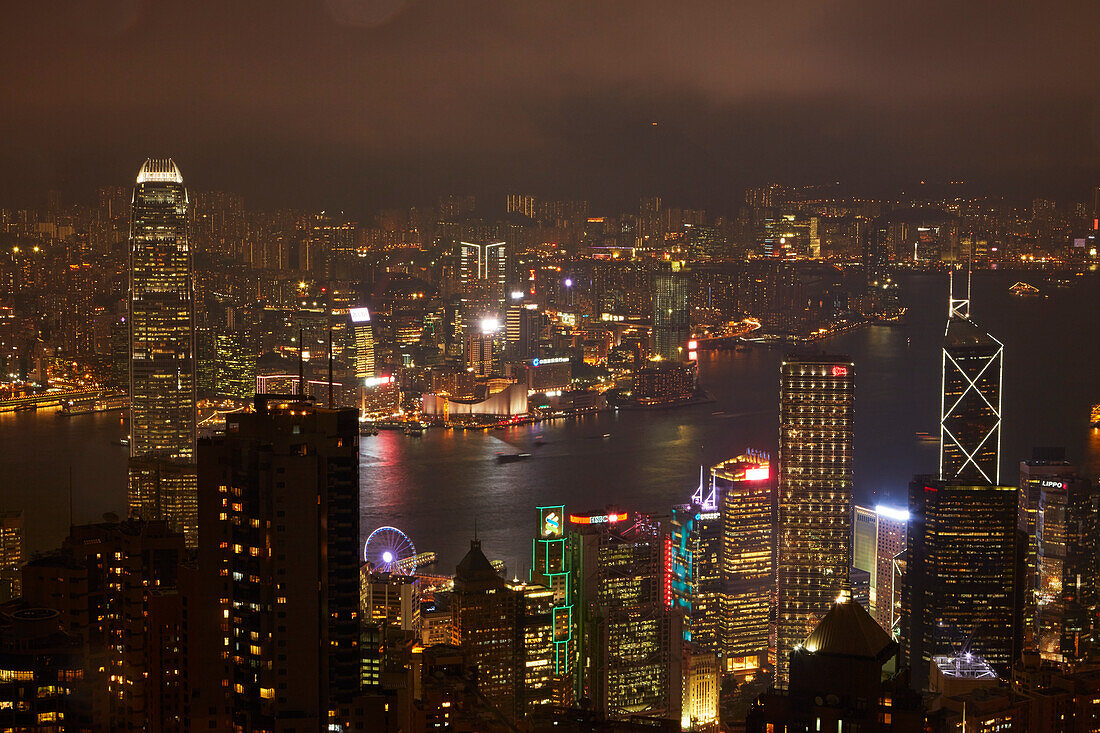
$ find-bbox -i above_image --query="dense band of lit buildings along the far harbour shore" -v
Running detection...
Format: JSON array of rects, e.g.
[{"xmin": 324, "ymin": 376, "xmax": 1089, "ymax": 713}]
[{"xmin": 0, "ymin": 171, "xmax": 1098, "ymax": 420}]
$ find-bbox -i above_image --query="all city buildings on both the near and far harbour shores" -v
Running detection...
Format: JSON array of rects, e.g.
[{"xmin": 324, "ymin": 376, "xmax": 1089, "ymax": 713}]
[{"xmin": 0, "ymin": 160, "xmax": 1100, "ymax": 733}]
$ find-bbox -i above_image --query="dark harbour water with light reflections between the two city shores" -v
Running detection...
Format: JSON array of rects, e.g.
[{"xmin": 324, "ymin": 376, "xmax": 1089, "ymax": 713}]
[{"xmin": 0, "ymin": 274, "xmax": 1100, "ymax": 575}]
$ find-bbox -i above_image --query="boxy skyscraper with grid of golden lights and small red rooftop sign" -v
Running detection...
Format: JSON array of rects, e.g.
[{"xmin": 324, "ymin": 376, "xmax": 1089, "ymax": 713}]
[{"xmin": 776, "ymin": 357, "xmax": 855, "ymax": 688}]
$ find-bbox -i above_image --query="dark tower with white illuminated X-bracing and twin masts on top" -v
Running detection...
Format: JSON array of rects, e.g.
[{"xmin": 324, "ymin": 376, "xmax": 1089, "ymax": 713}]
[{"xmin": 939, "ymin": 270, "xmax": 1004, "ymax": 485}]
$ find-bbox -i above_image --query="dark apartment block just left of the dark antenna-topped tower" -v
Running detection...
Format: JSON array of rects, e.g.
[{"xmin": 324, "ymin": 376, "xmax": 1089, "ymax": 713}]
[{"xmin": 23, "ymin": 519, "xmax": 189, "ymax": 731}]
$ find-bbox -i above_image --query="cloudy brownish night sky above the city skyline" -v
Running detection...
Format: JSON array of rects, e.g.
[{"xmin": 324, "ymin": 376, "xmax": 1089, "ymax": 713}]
[{"xmin": 0, "ymin": 0, "xmax": 1100, "ymax": 212}]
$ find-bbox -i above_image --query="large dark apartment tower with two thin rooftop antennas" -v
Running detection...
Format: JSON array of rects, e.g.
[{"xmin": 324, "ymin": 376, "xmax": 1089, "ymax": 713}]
[{"xmin": 191, "ymin": 395, "xmax": 361, "ymax": 731}]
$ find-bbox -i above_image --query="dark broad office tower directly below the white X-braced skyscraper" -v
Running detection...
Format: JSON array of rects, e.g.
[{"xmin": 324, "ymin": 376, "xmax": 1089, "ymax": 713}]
[{"xmin": 901, "ymin": 475, "xmax": 1023, "ymax": 690}]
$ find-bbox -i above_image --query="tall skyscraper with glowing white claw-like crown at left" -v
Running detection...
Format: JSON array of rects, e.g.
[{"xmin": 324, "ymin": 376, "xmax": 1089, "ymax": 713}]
[{"xmin": 129, "ymin": 158, "xmax": 197, "ymax": 545}]
